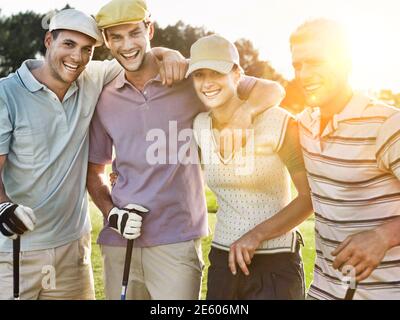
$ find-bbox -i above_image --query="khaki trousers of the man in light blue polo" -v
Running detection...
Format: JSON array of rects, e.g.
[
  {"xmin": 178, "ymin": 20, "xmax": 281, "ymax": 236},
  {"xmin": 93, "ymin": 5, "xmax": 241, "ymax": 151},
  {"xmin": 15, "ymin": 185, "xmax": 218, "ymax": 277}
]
[{"xmin": 0, "ymin": 234, "xmax": 95, "ymax": 300}]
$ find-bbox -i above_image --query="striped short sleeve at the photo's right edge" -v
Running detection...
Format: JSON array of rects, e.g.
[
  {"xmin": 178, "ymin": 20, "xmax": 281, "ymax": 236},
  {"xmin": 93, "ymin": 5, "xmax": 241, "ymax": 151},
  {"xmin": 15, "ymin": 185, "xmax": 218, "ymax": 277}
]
[{"xmin": 376, "ymin": 112, "xmax": 400, "ymax": 179}]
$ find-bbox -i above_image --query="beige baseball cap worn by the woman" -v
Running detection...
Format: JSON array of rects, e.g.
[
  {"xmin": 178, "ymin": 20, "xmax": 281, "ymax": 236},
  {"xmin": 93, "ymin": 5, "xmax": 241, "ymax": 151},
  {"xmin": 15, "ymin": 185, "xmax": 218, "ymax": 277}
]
[{"xmin": 186, "ymin": 34, "xmax": 240, "ymax": 78}]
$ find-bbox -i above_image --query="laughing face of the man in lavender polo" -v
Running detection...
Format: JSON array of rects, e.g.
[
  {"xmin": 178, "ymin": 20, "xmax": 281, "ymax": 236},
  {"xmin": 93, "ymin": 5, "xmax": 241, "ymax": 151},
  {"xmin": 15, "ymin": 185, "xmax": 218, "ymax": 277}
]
[{"xmin": 104, "ymin": 22, "xmax": 154, "ymax": 72}]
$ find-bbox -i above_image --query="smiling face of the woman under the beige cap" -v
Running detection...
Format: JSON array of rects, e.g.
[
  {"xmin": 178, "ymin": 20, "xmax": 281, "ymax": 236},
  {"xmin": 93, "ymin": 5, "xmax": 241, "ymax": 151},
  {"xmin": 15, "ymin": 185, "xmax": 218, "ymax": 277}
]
[{"xmin": 192, "ymin": 69, "xmax": 240, "ymax": 109}]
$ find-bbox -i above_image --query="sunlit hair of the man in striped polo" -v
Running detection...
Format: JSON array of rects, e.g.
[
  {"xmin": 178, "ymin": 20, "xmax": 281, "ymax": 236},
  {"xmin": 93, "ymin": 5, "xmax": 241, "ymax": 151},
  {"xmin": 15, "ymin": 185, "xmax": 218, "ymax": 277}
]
[{"xmin": 290, "ymin": 18, "xmax": 351, "ymax": 62}]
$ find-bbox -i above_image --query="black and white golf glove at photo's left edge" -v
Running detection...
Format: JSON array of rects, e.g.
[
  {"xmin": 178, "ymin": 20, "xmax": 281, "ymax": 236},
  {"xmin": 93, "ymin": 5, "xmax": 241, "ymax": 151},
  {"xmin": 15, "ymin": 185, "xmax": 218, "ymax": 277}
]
[{"xmin": 0, "ymin": 202, "xmax": 36, "ymax": 240}]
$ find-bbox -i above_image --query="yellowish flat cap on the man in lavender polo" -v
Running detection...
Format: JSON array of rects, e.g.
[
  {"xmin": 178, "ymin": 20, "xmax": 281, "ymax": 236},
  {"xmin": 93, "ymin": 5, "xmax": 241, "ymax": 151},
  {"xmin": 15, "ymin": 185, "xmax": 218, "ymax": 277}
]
[{"xmin": 96, "ymin": 0, "xmax": 150, "ymax": 29}]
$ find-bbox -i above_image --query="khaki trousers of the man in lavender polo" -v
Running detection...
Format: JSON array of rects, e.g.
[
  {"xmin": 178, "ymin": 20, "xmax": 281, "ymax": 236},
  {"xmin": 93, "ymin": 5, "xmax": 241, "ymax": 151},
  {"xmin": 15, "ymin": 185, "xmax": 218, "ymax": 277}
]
[{"xmin": 101, "ymin": 240, "xmax": 204, "ymax": 300}]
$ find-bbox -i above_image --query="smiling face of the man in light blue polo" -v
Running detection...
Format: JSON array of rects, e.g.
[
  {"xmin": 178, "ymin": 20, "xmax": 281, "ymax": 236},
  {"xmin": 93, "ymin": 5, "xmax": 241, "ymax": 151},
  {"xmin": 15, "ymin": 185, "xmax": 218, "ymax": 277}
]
[{"xmin": 45, "ymin": 30, "xmax": 96, "ymax": 85}]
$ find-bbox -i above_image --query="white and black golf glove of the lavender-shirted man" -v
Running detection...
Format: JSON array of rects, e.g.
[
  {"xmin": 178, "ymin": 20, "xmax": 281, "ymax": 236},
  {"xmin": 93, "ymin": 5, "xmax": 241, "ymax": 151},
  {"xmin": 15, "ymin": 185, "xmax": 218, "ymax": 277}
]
[{"xmin": 108, "ymin": 204, "xmax": 149, "ymax": 240}]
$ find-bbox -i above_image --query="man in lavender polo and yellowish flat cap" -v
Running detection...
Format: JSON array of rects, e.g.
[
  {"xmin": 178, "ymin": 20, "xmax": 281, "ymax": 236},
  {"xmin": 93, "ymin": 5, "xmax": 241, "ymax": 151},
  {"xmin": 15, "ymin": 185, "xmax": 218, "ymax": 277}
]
[{"xmin": 88, "ymin": 0, "xmax": 281, "ymax": 300}]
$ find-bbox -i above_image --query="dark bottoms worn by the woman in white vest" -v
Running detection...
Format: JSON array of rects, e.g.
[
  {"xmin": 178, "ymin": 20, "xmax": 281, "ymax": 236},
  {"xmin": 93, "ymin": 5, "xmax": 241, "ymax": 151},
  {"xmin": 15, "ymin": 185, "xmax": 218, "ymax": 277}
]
[{"xmin": 207, "ymin": 242, "xmax": 305, "ymax": 300}]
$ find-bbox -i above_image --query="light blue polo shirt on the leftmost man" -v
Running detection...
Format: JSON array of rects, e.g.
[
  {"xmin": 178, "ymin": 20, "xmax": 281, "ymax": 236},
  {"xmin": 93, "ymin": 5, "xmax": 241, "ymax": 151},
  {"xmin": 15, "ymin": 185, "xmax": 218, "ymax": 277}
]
[{"xmin": 0, "ymin": 60, "xmax": 121, "ymax": 252}]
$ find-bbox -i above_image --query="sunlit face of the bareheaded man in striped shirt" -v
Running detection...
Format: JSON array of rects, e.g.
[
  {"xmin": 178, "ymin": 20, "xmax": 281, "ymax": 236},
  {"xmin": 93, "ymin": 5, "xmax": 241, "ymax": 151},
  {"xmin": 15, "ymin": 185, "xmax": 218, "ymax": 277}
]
[{"xmin": 292, "ymin": 32, "xmax": 350, "ymax": 109}]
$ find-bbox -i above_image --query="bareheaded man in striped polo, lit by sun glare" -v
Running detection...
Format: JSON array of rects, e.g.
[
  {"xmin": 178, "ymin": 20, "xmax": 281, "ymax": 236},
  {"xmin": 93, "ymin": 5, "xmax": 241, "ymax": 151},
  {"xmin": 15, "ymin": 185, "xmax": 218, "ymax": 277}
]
[{"xmin": 290, "ymin": 19, "xmax": 400, "ymax": 299}]
